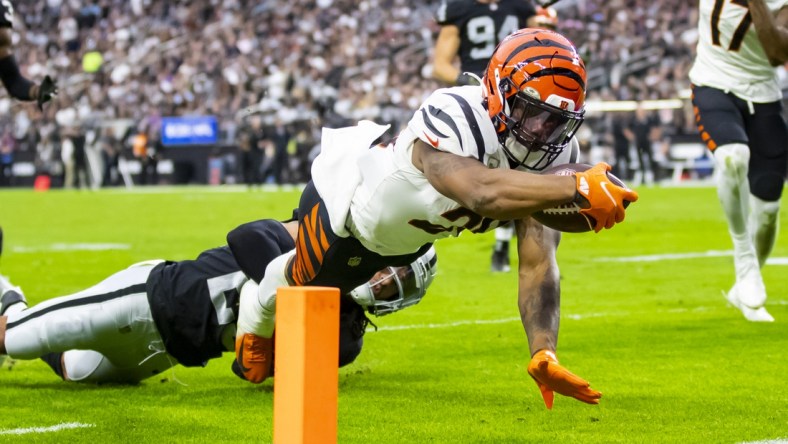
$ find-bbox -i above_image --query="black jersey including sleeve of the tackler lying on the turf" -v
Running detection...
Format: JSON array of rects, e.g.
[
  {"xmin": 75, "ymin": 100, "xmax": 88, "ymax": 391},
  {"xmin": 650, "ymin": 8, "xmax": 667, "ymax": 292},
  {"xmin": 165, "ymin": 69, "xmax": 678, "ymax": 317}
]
[{"xmin": 146, "ymin": 220, "xmax": 295, "ymax": 366}]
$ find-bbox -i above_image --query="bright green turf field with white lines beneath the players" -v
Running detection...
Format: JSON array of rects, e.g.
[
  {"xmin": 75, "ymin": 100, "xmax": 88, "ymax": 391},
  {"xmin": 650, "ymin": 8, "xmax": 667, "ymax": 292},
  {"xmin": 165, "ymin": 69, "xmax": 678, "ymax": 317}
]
[{"xmin": 0, "ymin": 188, "xmax": 788, "ymax": 443}]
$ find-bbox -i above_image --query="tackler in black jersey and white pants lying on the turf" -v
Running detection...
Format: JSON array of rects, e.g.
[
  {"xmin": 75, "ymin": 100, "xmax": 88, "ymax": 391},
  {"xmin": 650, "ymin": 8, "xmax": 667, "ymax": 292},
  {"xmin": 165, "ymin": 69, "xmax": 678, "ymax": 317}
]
[{"xmin": 0, "ymin": 220, "xmax": 437, "ymax": 383}]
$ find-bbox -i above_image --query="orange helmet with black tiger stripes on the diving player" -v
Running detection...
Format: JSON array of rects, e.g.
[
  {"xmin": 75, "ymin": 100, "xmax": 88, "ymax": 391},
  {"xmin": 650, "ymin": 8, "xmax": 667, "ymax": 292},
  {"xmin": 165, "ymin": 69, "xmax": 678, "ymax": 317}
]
[{"xmin": 482, "ymin": 28, "xmax": 586, "ymax": 170}]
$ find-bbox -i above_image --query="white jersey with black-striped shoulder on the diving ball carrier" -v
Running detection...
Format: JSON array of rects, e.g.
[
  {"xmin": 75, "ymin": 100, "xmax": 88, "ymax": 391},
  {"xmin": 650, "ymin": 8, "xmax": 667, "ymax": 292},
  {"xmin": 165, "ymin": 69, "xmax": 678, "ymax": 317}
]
[{"xmin": 340, "ymin": 86, "xmax": 577, "ymax": 256}]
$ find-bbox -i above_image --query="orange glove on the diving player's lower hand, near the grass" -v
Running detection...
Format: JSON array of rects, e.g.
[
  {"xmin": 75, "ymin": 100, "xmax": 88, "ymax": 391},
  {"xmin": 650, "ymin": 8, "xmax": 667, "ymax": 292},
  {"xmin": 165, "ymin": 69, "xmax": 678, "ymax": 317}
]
[{"xmin": 528, "ymin": 350, "xmax": 602, "ymax": 409}]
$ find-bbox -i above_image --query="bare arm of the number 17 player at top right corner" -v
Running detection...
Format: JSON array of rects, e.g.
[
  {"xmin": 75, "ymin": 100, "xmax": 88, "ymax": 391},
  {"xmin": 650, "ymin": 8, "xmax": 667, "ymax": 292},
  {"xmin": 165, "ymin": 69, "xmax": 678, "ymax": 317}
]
[{"xmin": 748, "ymin": 0, "xmax": 788, "ymax": 66}]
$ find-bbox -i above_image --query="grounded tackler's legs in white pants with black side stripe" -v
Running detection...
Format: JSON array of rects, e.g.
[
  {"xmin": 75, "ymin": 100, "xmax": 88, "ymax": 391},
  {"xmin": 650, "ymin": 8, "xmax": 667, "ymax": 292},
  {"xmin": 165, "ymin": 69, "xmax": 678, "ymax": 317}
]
[{"xmin": 5, "ymin": 265, "xmax": 176, "ymax": 382}]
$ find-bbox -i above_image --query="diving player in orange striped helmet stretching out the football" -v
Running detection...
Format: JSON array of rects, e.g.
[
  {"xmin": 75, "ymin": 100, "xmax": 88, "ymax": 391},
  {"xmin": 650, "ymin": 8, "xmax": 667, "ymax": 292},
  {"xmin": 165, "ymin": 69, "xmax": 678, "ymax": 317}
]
[{"xmin": 236, "ymin": 29, "xmax": 638, "ymax": 408}]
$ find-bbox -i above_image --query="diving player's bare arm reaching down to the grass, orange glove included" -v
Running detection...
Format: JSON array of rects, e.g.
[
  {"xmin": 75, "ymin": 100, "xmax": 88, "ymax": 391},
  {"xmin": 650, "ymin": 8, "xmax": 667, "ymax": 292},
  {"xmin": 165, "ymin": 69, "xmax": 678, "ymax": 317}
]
[{"xmin": 517, "ymin": 218, "xmax": 602, "ymax": 409}]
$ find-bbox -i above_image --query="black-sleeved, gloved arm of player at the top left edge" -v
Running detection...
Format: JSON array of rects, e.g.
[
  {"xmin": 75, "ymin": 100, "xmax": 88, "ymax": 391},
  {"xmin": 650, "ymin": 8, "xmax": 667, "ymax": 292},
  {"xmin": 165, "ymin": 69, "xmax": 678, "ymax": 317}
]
[{"xmin": 0, "ymin": 0, "xmax": 58, "ymax": 109}]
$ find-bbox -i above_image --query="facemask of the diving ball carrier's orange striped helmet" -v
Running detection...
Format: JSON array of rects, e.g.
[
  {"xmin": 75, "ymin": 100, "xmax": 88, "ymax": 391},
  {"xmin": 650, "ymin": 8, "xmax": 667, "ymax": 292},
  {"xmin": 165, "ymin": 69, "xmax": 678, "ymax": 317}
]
[{"xmin": 500, "ymin": 79, "xmax": 584, "ymax": 171}]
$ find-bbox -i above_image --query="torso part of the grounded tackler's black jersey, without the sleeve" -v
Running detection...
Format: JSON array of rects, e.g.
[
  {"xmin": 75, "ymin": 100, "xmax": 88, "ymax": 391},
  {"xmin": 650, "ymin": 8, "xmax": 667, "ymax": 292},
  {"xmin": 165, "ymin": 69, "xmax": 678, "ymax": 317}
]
[{"xmin": 146, "ymin": 247, "xmax": 248, "ymax": 366}]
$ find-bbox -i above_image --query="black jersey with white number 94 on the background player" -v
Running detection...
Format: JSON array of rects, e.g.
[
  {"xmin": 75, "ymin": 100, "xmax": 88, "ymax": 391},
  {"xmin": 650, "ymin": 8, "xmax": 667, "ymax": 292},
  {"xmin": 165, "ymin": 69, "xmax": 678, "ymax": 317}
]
[{"xmin": 436, "ymin": 0, "xmax": 536, "ymax": 77}]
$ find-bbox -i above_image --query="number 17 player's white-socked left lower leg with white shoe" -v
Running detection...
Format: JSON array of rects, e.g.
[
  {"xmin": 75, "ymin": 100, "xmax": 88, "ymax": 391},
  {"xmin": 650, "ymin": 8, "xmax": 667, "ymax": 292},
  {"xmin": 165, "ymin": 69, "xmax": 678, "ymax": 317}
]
[{"xmin": 714, "ymin": 143, "xmax": 771, "ymax": 320}]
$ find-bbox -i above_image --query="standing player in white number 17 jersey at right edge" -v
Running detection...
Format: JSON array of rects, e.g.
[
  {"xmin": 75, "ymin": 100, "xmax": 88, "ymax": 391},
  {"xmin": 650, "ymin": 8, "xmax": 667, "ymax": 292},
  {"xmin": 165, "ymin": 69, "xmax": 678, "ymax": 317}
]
[{"xmin": 689, "ymin": 0, "xmax": 788, "ymax": 322}]
